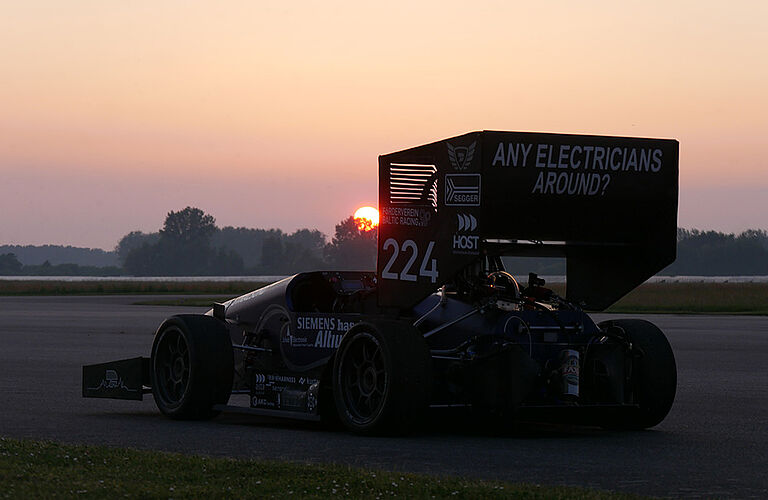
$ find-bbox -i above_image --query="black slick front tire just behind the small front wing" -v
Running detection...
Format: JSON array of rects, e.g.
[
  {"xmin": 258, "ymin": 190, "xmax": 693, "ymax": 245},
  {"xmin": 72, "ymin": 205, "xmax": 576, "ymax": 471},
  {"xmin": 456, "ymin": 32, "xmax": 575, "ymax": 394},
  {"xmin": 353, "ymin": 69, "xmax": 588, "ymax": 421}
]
[{"xmin": 150, "ymin": 314, "xmax": 234, "ymax": 420}]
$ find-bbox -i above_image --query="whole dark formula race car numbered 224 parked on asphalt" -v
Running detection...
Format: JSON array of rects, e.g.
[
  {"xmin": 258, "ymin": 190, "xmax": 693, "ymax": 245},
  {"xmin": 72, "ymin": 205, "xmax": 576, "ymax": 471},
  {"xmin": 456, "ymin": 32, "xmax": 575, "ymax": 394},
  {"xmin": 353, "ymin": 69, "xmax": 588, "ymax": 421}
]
[{"xmin": 83, "ymin": 131, "xmax": 678, "ymax": 434}]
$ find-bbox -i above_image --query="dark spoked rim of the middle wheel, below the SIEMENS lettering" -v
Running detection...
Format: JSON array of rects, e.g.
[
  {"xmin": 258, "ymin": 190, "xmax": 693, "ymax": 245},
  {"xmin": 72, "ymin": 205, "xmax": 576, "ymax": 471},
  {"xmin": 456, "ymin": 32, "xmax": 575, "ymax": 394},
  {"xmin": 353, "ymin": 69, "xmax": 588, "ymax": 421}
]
[{"xmin": 339, "ymin": 333, "xmax": 389, "ymax": 425}]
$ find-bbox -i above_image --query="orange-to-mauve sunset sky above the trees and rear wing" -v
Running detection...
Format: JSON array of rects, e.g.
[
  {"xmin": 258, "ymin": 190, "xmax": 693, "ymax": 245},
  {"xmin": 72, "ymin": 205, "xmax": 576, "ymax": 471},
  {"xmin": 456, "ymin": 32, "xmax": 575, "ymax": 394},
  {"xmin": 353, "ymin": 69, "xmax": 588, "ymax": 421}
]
[{"xmin": 0, "ymin": 0, "xmax": 768, "ymax": 248}]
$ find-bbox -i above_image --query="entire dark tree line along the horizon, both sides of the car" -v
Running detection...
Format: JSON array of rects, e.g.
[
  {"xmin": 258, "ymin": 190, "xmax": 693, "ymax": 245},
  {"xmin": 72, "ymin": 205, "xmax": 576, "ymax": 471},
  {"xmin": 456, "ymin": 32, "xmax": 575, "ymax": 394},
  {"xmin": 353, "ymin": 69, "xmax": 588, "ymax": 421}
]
[{"xmin": 0, "ymin": 207, "xmax": 768, "ymax": 276}]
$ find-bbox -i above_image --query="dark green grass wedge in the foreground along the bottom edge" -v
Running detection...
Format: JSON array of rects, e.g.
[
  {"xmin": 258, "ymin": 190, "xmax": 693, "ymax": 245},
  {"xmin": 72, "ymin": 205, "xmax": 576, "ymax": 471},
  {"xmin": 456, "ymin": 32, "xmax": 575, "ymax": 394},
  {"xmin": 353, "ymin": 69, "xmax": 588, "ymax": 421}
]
[{"xmin": 0, "ymin": 438, "xmax": 641, "ymax": 499}]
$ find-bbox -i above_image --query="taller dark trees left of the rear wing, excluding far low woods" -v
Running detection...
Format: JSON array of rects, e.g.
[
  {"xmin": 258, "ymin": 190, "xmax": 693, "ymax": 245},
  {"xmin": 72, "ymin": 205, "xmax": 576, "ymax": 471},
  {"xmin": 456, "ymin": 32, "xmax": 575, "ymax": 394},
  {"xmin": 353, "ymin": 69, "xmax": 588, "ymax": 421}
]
[{"xmin": 116, "ymin": 207, "xmax": 376, "ymax": 276}]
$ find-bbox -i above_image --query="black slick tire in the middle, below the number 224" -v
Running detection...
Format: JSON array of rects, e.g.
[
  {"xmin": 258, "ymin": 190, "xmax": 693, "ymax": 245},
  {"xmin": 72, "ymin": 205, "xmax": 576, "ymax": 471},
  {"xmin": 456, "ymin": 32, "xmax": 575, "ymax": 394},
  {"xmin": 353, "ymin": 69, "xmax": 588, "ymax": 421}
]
[{"xmin": 333, "ymin": 321, "xmax": 432, "ymax": 435}]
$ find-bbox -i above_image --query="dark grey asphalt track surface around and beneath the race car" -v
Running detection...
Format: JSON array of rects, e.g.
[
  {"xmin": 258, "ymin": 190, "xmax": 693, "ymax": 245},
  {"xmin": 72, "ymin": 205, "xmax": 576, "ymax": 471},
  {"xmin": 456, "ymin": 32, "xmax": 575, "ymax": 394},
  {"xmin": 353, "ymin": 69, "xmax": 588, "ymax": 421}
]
[{"xmin": 0, "ymin": 296, "xmax": 768, "ymax": 498}]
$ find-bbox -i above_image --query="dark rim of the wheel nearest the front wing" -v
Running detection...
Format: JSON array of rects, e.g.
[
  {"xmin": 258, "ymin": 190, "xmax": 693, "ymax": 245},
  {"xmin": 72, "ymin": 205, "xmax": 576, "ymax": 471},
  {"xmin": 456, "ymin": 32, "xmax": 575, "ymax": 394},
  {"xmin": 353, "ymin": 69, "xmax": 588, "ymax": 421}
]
[{"xmin": 155, "ymin": 328, "xmax": 190, "ymax": 406}]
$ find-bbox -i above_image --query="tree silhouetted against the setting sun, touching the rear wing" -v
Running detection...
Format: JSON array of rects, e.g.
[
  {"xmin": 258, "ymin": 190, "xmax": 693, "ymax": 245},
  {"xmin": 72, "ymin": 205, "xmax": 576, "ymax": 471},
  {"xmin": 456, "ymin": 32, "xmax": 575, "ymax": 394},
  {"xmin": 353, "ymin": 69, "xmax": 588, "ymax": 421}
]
[{"xmin": 325, "ymin": 216, "xmax": 378, "ymax": 271}]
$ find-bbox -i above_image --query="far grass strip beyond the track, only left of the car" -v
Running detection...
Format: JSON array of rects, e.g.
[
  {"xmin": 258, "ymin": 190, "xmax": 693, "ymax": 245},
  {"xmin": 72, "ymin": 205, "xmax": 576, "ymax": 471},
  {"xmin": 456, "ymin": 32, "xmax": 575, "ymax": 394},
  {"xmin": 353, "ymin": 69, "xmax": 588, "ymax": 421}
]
[{"xmin": 0, "ymin": 280, "xmax": 269, "ymax": 297}]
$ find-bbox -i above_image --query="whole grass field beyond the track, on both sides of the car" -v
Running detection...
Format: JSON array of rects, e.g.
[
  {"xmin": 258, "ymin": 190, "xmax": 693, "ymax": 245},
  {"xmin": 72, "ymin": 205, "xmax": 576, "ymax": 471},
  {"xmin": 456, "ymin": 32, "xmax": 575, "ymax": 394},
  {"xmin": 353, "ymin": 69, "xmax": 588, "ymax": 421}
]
[{"xmin": 0, "ymin": 281, "xmax": 768, "ymax": 315}]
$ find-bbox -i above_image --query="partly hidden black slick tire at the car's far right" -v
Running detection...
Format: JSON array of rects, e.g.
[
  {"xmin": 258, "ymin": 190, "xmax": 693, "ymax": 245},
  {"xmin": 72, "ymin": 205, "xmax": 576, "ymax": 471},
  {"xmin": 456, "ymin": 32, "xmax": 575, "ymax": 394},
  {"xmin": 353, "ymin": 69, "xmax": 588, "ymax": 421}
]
[{"xmin": 599, "ymin": 319, "xmax": 677, "ymax": 430}]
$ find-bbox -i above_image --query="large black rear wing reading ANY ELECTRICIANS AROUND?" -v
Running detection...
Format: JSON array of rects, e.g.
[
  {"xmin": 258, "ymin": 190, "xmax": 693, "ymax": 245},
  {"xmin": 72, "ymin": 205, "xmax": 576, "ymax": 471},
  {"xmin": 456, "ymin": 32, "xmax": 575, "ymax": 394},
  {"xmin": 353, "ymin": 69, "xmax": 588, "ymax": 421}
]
[{"xmin": 377, "ymin": 131, "xmax": 678, "ymax": 310}]
